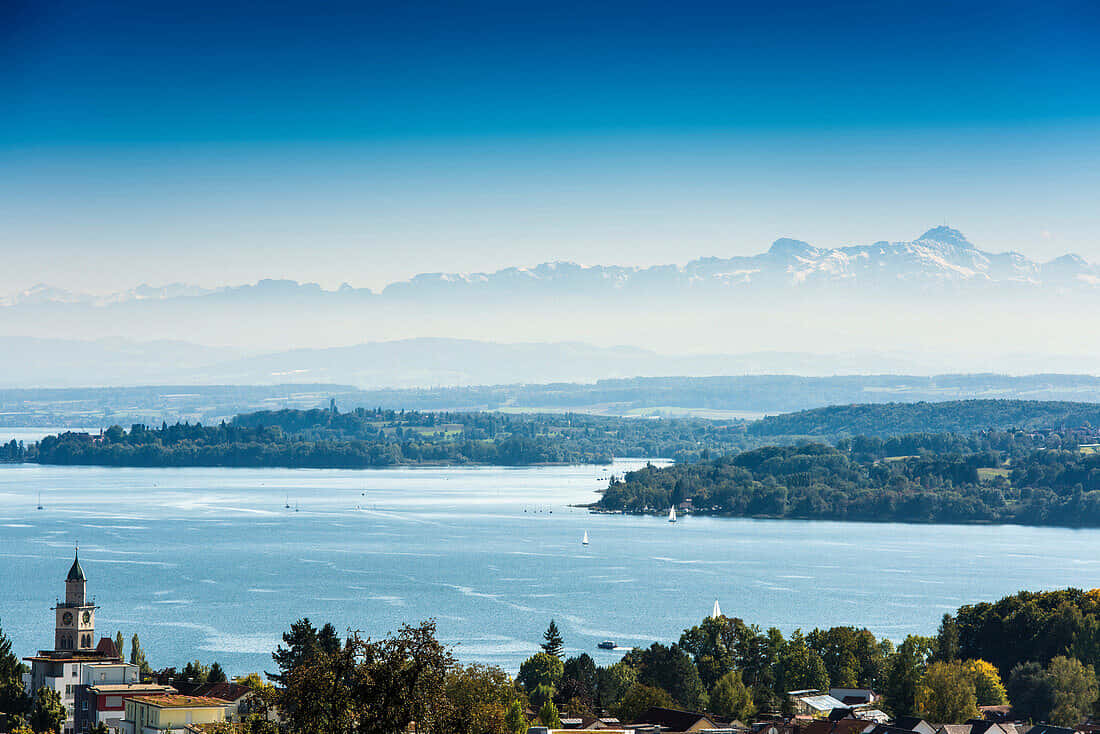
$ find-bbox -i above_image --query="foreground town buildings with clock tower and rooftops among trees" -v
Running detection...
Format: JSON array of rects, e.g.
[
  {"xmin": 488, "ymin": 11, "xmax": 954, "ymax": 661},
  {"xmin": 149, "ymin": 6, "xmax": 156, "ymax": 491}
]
[{"xmin": 12, "ymin": 554, "xmax": 1100, "ymax": 734}]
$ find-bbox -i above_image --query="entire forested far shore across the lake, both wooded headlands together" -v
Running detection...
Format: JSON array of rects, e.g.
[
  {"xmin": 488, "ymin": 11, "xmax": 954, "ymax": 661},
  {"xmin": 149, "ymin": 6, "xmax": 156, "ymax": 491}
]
[{"xmin": 0, "ymin": 401, "xmax": 1100, "ymax": 526}]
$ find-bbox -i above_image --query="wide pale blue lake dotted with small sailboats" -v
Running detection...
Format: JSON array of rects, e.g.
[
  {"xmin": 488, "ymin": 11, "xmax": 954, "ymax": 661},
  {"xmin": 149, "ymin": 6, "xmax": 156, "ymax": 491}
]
[{"xmin": 0, "ymin": 460, "xmax": 1100, "ymax": 673}]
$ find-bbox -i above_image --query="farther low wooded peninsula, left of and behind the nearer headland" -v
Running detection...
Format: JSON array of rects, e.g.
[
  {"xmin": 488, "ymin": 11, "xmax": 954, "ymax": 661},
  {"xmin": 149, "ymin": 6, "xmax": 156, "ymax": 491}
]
[{"xmin": 10, "ymin": 406, "xmax": 745, "ymax": 469}]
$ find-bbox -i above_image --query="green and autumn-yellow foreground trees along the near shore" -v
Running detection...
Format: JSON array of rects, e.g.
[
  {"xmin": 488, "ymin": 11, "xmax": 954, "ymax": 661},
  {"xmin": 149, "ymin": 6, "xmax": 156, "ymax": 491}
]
[{"xmin": 0, "ymin": 589, "xmax": 1100, "ymax": 734}]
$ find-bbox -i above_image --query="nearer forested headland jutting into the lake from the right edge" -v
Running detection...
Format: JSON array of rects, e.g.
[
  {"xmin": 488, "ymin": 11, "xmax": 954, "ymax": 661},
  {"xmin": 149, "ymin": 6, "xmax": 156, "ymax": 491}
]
[{"xmin": 595, "ymin": 429, "xmax": 1100, "ymax": 527}]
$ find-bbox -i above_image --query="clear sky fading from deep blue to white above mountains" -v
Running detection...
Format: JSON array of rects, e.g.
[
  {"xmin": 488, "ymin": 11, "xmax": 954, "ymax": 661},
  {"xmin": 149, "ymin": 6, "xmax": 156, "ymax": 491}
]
[{"xmin": 0, "ymin": 0, "xmax": 1100, "ymax": 294}]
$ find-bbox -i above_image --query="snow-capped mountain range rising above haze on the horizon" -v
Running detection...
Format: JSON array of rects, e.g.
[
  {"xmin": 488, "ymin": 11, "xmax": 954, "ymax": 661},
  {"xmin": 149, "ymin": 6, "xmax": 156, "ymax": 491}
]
[{"xmin": 0, "ymin": 227, "xmax": 1100, "ymax": 307}]
